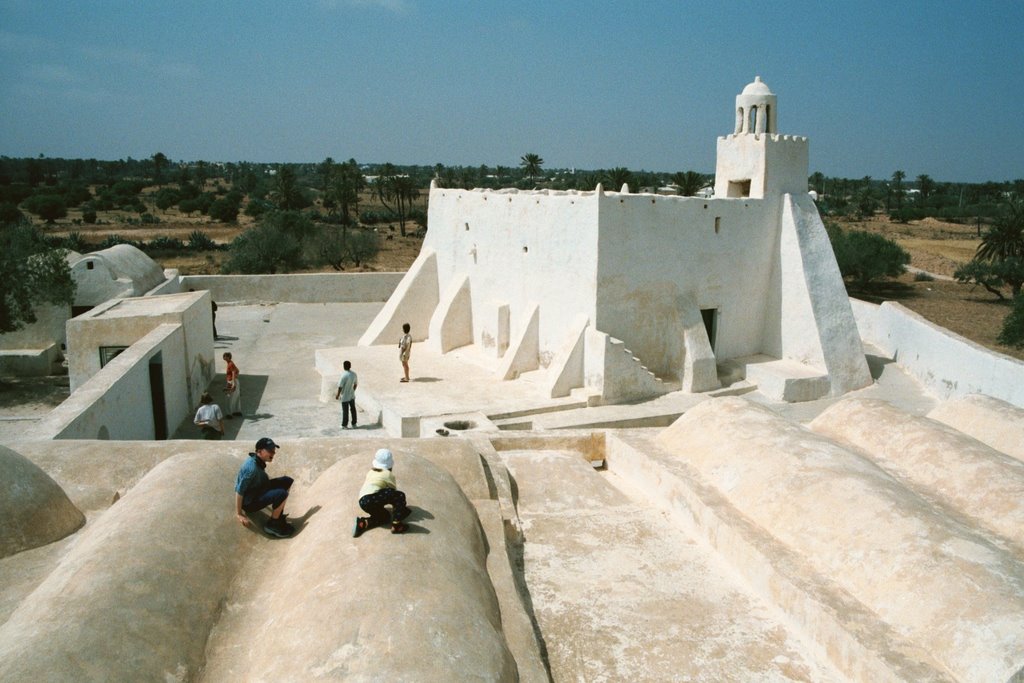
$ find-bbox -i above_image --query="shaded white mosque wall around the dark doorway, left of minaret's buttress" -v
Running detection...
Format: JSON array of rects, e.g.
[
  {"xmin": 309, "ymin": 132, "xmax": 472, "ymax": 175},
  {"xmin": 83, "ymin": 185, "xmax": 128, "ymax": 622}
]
[{"xmin": 597, "ymin": 193, "xmax": 778, "ymax": 377}]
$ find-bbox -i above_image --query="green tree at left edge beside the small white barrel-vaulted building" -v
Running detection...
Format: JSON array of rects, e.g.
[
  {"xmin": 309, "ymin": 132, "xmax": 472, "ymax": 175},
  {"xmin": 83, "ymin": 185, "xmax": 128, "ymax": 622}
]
[{"xmin": 0, "ymin": 221, "xmax": 75, "ymax": 333}]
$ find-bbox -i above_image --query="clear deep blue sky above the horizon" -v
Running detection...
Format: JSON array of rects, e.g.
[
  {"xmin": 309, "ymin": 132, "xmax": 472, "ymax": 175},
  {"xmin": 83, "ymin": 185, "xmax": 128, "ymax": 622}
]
[{"xmin": 0, "ymin": 0, "xmax": 1024, "ymax": 181}]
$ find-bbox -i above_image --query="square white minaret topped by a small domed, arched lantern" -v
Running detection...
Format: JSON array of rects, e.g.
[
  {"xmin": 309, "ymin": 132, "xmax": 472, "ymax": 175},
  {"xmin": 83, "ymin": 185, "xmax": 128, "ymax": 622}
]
[{"xmin": 715, "ymin": 76, "xmax": 808, "ymax": 199}]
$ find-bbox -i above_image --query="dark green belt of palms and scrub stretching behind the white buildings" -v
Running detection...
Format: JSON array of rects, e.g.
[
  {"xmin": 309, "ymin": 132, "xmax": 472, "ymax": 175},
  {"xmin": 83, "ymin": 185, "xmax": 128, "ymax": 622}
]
[{"xmin": 0, "ymin": 152, "xmax": 1024, "ymax": 345}]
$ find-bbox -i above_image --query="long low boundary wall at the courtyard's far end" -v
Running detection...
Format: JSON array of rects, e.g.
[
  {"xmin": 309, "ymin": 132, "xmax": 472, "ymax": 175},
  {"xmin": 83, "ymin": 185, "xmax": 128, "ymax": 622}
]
[{"xmin": 181, "ymin": 272, "xmax": 406, "ymax": 303}]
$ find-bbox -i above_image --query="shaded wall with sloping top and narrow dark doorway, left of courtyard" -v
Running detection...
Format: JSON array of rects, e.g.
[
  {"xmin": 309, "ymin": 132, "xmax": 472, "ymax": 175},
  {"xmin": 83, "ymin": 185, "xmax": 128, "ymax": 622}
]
[{"xmin": 26, "ymin": 324, "xmax": 191, "ymax": 440}]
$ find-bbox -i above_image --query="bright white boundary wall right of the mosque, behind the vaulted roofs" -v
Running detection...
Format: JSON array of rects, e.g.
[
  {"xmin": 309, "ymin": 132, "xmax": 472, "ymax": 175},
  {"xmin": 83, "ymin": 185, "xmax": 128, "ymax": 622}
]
[{"xmin": 850, "ymin": 299, "xmax": 1024, "ymax": 408}]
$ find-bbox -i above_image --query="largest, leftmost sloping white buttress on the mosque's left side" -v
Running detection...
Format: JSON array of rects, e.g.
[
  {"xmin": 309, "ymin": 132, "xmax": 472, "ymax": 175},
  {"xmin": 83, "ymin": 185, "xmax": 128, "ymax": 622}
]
[{"xmin": 358, "ymin": 247, "xmax": 440, "ymax": 346}]
